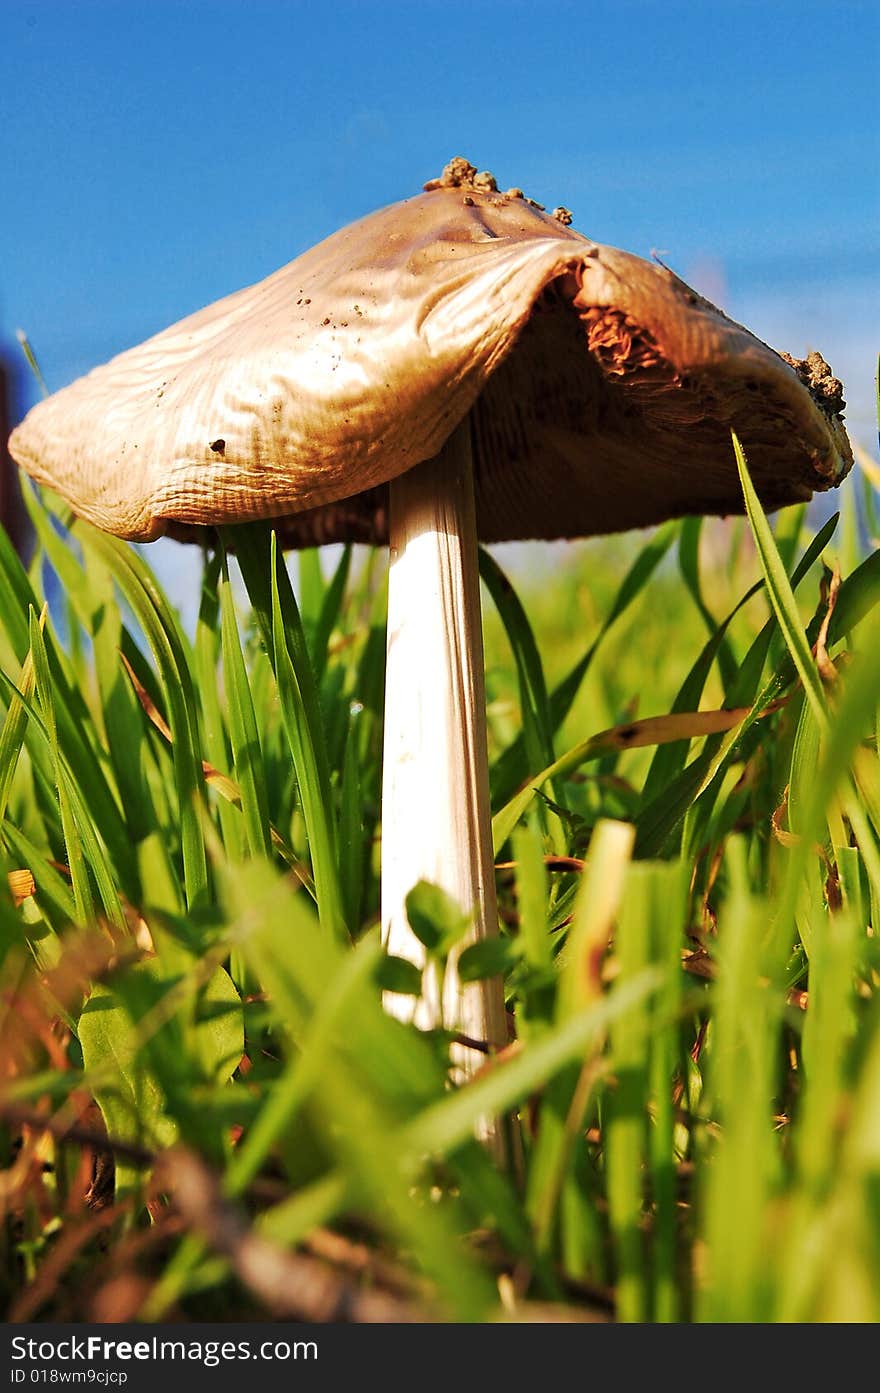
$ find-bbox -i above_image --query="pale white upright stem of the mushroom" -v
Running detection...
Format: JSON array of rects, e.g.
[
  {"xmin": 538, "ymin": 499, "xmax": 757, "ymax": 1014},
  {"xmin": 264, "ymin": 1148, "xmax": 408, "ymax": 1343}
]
[{"xmin": 382, "ymin": 418, "xmax": 507, "ymax": 1074}]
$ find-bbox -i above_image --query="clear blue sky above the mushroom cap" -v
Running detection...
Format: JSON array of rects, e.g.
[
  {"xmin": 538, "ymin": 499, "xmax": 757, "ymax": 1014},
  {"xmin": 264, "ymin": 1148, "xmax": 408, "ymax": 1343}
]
[{"xmin": 0, "ymin": 0, "xmax": 880, "ymax": 593}]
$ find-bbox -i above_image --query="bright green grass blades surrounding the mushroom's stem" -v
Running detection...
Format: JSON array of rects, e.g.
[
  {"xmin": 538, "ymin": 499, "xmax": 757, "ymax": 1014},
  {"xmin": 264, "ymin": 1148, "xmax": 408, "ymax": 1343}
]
[{"xmin": 0, "ymin": 431, "xmax": 880, "ymax": 1322}]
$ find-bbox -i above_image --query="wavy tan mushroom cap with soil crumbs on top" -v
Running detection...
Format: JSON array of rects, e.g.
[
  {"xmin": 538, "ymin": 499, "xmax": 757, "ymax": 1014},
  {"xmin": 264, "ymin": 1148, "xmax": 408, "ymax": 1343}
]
[{"xmin": 10, "ymin": 184, "xmax": 852, "ymax": 546}]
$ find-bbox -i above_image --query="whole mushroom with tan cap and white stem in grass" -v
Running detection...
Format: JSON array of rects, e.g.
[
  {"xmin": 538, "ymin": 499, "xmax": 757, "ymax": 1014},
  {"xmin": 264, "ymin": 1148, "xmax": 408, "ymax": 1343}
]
[{"xmin": 10, "ymin": 159, "xmax": 851, "ymax": 1075}]
